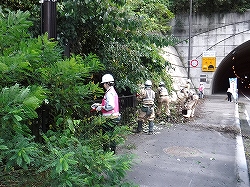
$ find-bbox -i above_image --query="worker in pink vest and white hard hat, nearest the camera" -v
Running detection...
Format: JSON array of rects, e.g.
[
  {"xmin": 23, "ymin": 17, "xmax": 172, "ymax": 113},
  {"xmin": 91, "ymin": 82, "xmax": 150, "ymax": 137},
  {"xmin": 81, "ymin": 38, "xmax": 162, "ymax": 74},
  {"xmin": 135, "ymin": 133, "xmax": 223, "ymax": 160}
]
[{"xmin": 92, "ymin": 74, "xmax": 121, "ymax": 153}]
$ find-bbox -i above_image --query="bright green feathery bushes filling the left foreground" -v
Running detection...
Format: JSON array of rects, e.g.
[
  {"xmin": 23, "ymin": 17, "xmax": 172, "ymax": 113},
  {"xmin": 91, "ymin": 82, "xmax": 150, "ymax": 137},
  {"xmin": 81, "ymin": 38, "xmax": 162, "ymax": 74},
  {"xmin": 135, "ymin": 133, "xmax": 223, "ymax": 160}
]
[{"xmin": 0, "ymin": 11, "xmax": 135, "ymax": 187}]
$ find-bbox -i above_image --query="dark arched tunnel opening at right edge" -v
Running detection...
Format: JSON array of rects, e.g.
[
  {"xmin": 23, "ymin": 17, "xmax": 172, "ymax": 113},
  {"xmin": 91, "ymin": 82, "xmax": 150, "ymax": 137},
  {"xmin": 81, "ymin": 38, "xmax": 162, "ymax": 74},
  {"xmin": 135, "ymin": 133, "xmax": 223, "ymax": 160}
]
[{"xmin": 212, "ymin": 40, "xmax": 250, "ymax": 94}]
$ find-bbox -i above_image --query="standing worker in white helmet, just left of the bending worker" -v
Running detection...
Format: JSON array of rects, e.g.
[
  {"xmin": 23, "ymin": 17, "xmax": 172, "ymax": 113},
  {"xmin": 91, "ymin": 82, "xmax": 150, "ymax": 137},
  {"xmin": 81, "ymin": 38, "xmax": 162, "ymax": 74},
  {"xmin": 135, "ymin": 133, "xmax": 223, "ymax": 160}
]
[{"xmin": 156, "ymin": 81, "xmax": 170, "ymax": 121}]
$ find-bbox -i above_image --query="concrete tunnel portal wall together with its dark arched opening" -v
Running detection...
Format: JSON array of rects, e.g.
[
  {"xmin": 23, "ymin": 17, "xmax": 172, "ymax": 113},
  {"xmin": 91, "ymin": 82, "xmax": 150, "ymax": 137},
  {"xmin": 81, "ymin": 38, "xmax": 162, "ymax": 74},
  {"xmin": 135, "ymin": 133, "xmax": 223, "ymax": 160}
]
[{"xmin": 169, "ymin": 10, "xmax": 250, "ymax": 95}]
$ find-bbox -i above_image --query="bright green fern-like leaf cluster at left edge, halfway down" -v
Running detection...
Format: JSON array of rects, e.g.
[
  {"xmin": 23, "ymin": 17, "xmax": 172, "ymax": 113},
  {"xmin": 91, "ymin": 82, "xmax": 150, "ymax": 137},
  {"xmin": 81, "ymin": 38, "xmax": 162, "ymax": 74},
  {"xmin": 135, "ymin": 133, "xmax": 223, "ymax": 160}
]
[{"xmin": 0, "ymin": 84, "xmax": 44, "ymax": 138}]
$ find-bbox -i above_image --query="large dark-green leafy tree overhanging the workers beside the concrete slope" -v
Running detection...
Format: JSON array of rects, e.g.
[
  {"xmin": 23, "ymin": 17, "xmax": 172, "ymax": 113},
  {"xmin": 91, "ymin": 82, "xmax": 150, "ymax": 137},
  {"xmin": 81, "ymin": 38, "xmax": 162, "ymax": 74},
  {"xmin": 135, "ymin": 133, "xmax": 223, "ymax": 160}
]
[{"xmin": 58, "ymin": 0, "xmax": 177, "ymax": 91}]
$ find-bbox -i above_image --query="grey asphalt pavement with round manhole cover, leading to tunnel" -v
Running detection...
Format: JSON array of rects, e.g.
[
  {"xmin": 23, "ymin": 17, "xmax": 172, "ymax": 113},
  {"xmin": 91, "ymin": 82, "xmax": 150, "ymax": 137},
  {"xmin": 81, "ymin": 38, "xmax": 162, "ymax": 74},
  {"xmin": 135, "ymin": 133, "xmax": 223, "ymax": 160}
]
[{"xmin": 118, "ymin": 95, "xmax": 249, "ymax": 187}]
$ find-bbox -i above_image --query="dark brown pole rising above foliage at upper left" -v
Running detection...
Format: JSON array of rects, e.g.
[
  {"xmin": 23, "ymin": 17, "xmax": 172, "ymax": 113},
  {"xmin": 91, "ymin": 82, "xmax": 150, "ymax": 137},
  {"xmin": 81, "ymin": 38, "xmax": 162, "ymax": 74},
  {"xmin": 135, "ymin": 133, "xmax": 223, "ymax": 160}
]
[{"xmin": 39, "ymin": 0, "xmax": 57, "ymax": 39}]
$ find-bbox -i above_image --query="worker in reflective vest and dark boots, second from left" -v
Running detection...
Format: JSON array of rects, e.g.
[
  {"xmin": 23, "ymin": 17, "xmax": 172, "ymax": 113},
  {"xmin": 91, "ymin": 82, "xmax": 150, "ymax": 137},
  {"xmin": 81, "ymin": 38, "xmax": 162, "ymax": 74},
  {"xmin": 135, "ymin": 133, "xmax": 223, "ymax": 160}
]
[{"xmin": 136, "ymin": 80, "xmax": 155, "ymax": 134}]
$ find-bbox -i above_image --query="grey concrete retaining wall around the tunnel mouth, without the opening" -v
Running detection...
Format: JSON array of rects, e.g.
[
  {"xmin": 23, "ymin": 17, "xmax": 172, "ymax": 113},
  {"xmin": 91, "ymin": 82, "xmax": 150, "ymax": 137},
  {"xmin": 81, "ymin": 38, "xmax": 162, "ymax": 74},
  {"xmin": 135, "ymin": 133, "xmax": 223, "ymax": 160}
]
[{"xmin": 168, "ymin": 10, "xmax": 250, "ymax": 94}]
